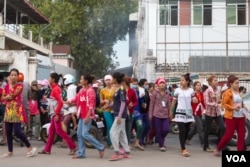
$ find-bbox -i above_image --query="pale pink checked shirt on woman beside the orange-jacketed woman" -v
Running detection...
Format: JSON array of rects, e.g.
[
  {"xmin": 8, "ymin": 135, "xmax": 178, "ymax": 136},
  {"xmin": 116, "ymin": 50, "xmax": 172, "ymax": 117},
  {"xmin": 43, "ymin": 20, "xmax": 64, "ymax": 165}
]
[{"xmin": 204, "ymin": 86, "xmax": 221, "ymax": 117}]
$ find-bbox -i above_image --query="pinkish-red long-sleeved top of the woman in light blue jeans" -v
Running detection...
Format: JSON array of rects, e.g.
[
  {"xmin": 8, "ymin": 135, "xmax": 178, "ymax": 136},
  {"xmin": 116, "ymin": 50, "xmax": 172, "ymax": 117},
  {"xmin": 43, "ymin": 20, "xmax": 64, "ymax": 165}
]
[{"xmin": 70, "ymin": 87, "xmax": 96, "ymax": 119}]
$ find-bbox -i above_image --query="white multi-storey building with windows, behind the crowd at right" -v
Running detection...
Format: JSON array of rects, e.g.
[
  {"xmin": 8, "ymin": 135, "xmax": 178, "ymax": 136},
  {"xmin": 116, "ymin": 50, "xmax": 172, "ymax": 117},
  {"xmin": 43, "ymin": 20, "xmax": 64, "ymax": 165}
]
[{"xmin": 131, "ymin": 0, "xmax": 250, "ymax": 81}]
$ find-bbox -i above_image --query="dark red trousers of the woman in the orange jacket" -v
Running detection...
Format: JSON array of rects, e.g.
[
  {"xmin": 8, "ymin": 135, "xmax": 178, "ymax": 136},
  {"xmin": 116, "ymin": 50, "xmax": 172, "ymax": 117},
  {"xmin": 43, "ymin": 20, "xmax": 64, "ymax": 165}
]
[{"xmin": 217, "ymin": 117, "xmax": 246, "ymax": 151}]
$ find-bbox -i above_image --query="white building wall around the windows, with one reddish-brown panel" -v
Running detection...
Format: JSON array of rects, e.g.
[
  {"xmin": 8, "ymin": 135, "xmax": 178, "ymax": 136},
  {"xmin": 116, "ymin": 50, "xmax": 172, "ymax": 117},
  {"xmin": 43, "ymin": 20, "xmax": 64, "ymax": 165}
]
[{"xmin": 133, "ymin": 0, "xmax": 250, "ymax": 77}]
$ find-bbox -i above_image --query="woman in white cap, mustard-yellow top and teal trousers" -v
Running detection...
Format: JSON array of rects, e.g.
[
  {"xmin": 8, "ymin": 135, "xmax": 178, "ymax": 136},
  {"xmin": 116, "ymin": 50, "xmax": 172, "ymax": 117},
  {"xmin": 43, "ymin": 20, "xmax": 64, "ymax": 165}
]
[{"xmin": 100, "ymin": 75, "xmax": 116, "ymax": 147}]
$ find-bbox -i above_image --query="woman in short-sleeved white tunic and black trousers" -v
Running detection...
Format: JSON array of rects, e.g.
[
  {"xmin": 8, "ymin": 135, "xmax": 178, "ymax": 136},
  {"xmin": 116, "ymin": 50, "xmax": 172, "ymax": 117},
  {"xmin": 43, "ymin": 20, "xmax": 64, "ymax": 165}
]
[{"xmin": 171, "ymin": 73, "xmax": 197, "ymax": 157}]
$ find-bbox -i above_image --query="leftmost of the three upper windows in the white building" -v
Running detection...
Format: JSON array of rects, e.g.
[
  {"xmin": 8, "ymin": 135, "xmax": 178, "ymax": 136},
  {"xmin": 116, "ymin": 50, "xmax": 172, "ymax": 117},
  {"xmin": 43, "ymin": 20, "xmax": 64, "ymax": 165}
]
[{"xmin": 159, "ymin": 0, "xmax": 178, "ymax": 26}]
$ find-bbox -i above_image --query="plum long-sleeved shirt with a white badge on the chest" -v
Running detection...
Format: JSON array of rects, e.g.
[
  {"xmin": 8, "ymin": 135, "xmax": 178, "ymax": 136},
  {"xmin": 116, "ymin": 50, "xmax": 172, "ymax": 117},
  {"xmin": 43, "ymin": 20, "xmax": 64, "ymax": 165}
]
[{"xmin": 149, "ymin": 91, "xmax": 170, "ymax": 118}]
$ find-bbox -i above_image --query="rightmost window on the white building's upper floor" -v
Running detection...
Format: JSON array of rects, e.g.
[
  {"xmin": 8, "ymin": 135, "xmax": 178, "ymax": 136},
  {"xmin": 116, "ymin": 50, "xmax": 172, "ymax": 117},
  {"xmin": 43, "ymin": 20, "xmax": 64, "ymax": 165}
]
[{"xmin": 227, "ymin": 0, "xmax": 247, "ymax": 25}]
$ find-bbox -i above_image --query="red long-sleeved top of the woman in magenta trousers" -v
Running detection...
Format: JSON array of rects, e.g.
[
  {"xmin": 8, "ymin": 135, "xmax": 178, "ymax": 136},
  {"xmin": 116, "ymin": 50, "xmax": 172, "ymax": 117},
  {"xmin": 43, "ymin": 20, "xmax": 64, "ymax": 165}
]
[{"xmin": 50, "ymin": 84, "xmax": 63, "ymax": 115}]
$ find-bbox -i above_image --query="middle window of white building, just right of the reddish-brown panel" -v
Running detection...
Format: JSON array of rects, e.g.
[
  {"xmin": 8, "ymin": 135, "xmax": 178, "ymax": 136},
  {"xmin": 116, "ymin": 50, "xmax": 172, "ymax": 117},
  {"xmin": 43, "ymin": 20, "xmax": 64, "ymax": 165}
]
[{"xmin": 193, "ymin": 0, "xmax": 212, "ymax": 25}]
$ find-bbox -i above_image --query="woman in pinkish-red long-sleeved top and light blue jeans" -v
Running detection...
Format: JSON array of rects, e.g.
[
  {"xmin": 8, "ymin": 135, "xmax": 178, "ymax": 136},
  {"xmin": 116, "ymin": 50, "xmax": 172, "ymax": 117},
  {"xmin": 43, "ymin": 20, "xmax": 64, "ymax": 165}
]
[{"xmin": 69, "ymin": 75, "xmax": 105, "ymax": 159}]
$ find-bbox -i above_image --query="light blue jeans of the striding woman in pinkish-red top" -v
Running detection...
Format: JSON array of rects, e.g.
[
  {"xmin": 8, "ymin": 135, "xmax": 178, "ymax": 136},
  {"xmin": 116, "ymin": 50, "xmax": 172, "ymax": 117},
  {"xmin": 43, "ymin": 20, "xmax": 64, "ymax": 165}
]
[{"xmin": 77, "ymin": 118, "xmax": 104, "ymax": 158}]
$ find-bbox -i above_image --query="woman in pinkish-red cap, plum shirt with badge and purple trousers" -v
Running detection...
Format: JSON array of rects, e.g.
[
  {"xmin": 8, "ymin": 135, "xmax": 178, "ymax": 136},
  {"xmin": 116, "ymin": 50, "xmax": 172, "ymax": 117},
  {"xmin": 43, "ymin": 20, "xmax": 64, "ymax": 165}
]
[{"xmin": 149, "ymin": 78, "xmax": 170, "ymax": 152}]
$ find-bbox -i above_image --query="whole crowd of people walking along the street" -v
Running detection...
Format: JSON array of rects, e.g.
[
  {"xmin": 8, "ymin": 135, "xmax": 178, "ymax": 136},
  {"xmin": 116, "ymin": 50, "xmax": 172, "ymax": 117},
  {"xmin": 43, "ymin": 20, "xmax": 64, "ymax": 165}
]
[{"xmin": 0, "ymin": 69, "xmax": 248, "ymax": 161}]
